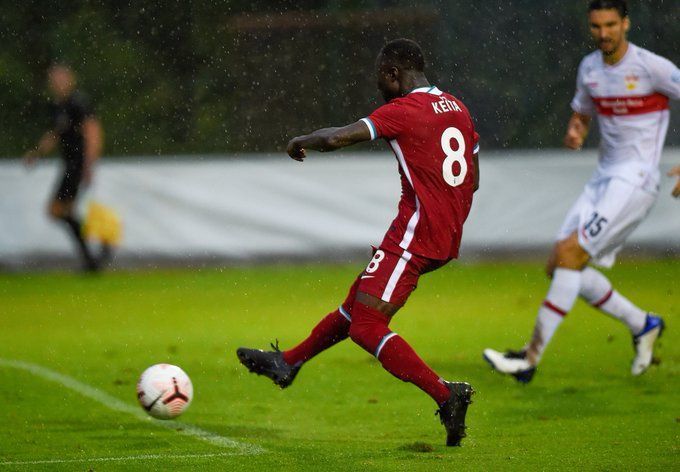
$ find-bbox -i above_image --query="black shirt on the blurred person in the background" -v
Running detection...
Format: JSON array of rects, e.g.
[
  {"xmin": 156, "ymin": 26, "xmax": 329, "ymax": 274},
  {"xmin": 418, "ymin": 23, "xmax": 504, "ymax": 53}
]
[{"xmin": 50, "ymin": 90, "xmax": 94, "ymax": 165}]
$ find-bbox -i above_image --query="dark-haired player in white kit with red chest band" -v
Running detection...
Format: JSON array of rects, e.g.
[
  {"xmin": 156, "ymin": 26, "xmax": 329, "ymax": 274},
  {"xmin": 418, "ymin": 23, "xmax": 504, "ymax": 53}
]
[{"xmin": 484, "ymin": 0, "xmax": 680, "ymax": 383}]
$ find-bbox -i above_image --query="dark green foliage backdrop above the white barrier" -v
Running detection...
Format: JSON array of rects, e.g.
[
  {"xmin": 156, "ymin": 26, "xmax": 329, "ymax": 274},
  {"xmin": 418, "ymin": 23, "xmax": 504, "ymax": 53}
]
[{"xmin": 0, "ymin": 0, "xmax": 680, "ymax": 156}]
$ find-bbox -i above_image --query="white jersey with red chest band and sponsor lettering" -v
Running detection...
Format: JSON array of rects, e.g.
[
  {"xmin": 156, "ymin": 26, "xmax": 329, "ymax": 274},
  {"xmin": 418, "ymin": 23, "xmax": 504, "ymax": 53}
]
[{"xmin": 571, "ymin": 43, "xmax": 680, "ymax": 188}]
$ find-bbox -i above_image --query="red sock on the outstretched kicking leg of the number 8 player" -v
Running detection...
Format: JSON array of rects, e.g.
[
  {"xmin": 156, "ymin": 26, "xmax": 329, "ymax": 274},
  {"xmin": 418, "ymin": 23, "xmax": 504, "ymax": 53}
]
[{"xmin": 283, "ymin": 310, "xmax": 349, "ymax": 365}]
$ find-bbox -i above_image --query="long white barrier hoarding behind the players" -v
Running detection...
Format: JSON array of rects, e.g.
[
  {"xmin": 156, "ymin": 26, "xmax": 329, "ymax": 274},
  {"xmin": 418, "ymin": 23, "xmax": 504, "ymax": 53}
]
[{"xmin": 0, "ymin": 149, "xmax": 680, "ymax": 263}]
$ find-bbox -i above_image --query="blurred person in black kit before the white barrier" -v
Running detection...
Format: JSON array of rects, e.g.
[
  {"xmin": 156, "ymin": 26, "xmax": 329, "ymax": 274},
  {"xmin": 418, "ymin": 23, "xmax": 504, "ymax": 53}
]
[{"xmin": 24, "ymin": 65, "xmax": 109, "ymax": 271}]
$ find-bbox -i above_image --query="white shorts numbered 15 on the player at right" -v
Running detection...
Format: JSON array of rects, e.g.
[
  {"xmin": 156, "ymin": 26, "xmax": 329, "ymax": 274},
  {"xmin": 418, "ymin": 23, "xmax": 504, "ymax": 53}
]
[{"xmin": 557, "ymin": 177, "xmax": 658, "ymax": 268}]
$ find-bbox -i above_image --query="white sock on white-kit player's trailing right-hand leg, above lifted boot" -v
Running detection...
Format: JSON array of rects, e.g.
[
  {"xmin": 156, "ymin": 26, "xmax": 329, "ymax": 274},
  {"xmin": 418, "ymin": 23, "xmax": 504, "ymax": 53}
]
[{"xmin": 580, "ymin": 267, "xmax": 647, "ymax": 334}]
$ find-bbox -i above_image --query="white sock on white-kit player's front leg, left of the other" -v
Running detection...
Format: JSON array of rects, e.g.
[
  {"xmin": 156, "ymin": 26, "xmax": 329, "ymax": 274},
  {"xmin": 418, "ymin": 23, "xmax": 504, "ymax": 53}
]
[{"xmin": 527, "ymin": 268, "xmax": 581, "ymax": 365}]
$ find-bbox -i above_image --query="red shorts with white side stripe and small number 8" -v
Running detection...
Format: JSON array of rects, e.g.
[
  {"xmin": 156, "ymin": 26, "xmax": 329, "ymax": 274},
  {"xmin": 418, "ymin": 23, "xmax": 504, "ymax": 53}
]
[{"xmin": 342, "ymin": 241, "xmax": 449, "ymax": 313}]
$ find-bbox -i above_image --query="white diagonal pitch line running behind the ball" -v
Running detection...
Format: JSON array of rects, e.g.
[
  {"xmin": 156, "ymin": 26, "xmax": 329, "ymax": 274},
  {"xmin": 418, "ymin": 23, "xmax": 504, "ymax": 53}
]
[{"xmin": 0, "ymin": 358, "xmax": 265, "ymax": 455}]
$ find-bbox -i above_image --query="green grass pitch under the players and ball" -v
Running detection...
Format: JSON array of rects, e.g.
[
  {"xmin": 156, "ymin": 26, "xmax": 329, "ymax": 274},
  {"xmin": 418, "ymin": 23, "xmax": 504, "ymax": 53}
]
[{"xmin": 0, "ymin": 261, "xmax": 680, "ymax": 472}]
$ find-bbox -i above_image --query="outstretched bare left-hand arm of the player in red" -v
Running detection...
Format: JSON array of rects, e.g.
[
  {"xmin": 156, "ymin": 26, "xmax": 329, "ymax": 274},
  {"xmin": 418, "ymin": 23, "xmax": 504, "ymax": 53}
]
[{"xmin": 286, "ymin": 121, "xmax": 371, "ymax": 162}]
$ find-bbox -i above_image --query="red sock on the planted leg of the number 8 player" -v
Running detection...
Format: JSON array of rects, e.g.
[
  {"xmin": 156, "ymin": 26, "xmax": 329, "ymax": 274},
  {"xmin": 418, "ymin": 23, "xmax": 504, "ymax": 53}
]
[{"xmin": 350, "ymin": 302, "xmax": 451, "ymax": 405}]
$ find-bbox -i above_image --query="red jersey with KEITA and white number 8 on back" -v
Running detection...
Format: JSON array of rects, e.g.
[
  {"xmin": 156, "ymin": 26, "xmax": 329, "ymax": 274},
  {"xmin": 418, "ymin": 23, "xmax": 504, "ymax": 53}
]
[{"xmin": 363, "ymin": 87, "xmax": 479, "ymax": 260}]
